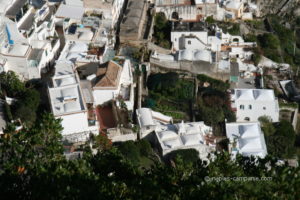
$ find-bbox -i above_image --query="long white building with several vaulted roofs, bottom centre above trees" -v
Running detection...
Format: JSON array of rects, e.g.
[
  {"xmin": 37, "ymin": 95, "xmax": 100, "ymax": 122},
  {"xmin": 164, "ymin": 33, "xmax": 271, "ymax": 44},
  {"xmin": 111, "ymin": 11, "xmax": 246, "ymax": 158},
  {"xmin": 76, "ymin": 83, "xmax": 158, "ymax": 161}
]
[{"xmin": 136, "ymin": 108, "xmax": 215, "ymax": 160}]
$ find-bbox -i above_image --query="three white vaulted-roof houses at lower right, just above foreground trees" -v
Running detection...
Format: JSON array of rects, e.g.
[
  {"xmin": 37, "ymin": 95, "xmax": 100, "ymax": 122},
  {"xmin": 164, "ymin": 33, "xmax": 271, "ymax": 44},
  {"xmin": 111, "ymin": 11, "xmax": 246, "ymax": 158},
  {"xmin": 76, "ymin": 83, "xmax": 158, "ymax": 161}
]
[{"xmin": 136, "ymin": 85, "xmax": 279, "ymax": 160}]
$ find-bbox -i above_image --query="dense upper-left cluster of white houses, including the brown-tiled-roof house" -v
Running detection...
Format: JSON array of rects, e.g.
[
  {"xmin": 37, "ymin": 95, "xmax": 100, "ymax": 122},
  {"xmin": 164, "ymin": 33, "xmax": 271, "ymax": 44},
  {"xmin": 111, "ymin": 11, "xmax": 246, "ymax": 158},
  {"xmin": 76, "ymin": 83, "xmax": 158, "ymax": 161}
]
[{"xmin": 0, "ymin": 0, "xmax": 135, "ymax": 142}]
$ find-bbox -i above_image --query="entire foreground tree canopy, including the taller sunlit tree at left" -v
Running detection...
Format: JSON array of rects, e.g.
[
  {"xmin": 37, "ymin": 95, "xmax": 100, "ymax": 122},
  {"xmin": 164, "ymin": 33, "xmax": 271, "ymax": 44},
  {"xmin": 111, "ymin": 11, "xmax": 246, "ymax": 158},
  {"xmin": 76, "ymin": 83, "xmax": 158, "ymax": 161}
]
[{"xmin": 0, "ymin": 114, "xmax": 300, "ymax": 200}]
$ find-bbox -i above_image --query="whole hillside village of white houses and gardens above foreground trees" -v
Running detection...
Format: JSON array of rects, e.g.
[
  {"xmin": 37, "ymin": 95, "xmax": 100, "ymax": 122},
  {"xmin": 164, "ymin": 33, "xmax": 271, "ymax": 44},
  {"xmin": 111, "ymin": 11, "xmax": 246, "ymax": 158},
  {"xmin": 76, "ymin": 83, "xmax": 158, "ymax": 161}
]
[{"xmin": 0, "ymin": 0, "xmax": 300, "ymax": 199}]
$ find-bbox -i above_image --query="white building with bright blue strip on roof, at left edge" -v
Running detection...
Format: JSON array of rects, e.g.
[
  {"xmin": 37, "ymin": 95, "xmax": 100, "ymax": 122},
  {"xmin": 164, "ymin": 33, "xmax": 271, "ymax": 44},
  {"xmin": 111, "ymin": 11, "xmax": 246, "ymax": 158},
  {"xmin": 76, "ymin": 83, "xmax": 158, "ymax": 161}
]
[{"xmin": 0, "ymin": 19, "xmax": 60, "ymax": 80}]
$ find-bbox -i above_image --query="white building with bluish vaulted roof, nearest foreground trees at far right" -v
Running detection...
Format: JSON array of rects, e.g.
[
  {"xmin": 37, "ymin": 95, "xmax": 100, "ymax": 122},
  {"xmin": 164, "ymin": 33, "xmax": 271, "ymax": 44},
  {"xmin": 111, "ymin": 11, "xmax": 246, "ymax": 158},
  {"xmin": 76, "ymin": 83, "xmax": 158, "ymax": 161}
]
[{"xmin": 226, "ymin": 122, "xmax": 267, "ymax": 158}]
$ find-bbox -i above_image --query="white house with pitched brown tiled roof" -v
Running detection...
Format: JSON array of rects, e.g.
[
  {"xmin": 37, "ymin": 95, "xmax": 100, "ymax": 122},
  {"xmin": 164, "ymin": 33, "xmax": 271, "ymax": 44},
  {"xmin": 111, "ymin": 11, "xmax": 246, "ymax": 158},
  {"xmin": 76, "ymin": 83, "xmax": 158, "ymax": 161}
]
[{"xmin": 76, "ymin": 58, "xmax": 135, "ymax": 110}]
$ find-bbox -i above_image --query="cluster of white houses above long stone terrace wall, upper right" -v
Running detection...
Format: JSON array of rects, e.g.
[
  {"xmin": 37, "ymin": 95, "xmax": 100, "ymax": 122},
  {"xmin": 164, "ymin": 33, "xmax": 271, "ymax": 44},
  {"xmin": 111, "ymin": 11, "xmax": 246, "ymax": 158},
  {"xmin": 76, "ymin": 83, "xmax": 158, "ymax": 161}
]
[{"xmin": 150, "ymin": 22, "xmax": 262, "ymax": 87}]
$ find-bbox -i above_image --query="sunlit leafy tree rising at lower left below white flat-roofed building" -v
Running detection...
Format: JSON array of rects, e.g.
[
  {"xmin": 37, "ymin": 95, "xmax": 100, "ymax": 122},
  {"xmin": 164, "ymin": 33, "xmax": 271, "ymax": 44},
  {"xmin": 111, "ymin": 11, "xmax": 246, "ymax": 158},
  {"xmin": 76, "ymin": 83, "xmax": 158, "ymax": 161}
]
[{"xmin": 0, "ymin": 114, "xmax": 63, "ymax": 173}]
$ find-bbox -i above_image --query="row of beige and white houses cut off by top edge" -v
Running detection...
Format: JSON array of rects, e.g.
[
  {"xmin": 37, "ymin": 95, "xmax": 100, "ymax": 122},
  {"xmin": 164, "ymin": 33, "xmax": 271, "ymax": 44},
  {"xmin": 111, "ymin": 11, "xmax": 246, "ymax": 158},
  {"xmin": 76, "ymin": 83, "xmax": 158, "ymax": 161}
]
[{"xmin": 155, "ymin": 0, "xmax": 260, "ymax": 22}]
